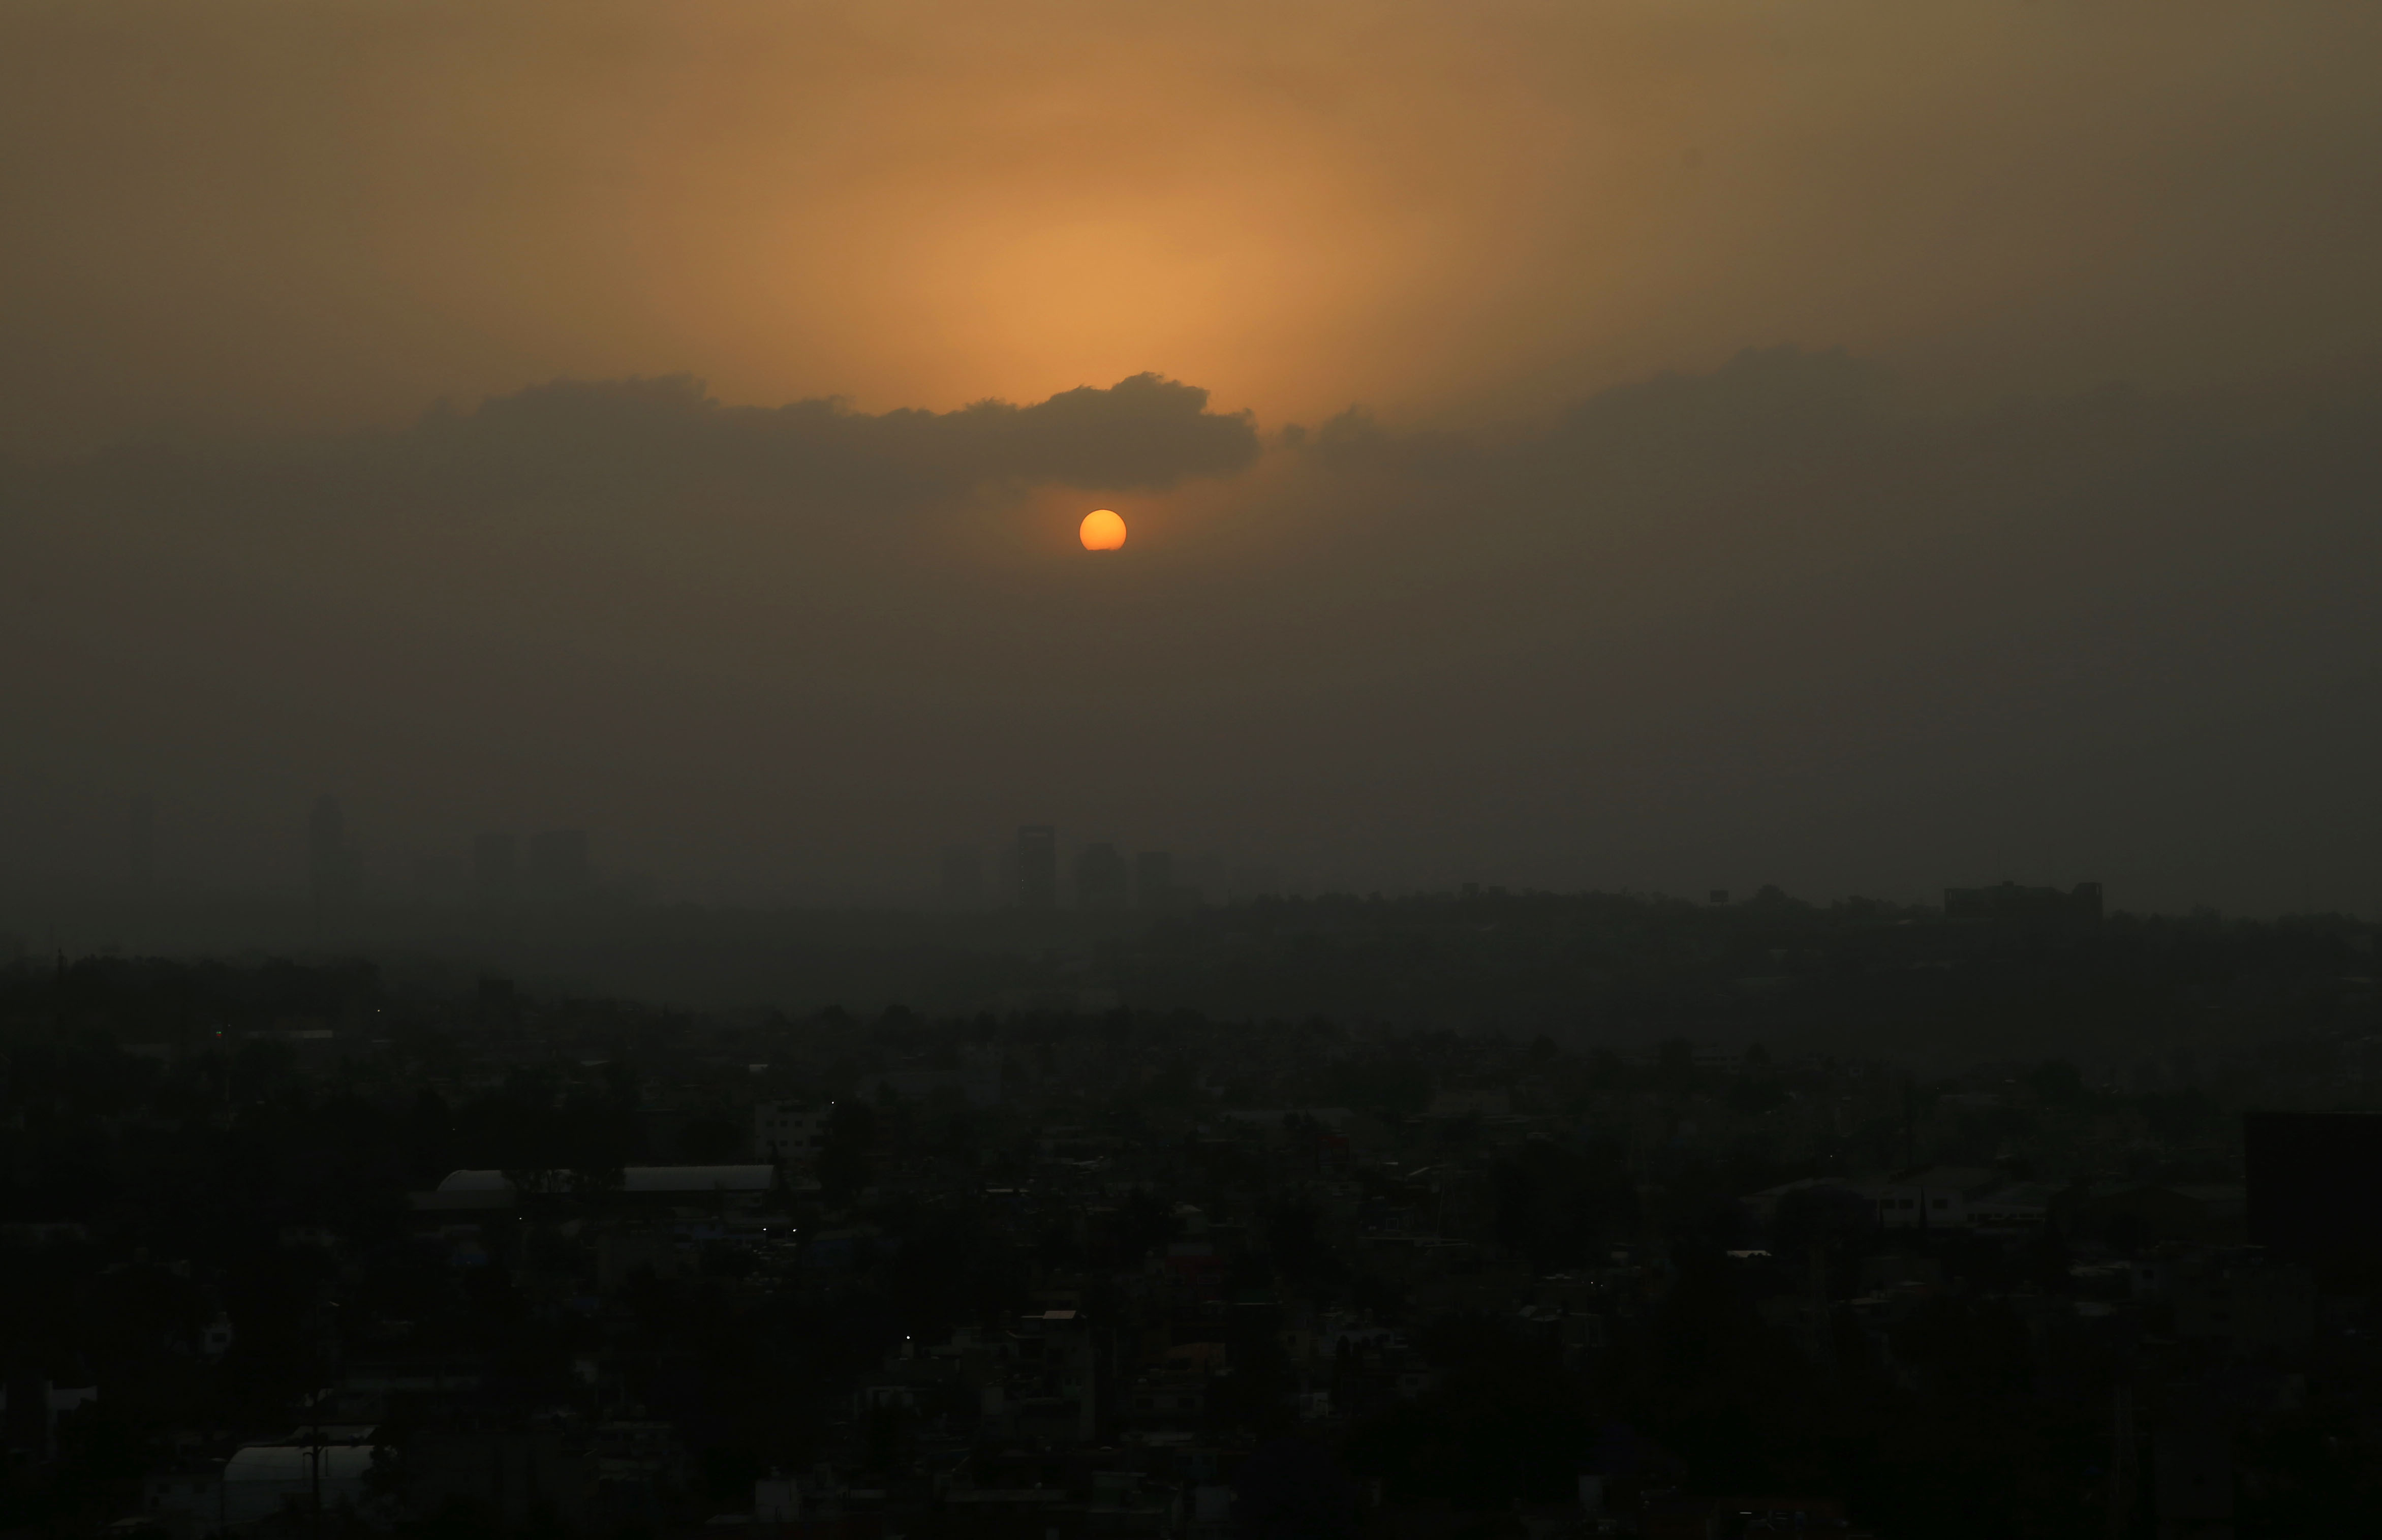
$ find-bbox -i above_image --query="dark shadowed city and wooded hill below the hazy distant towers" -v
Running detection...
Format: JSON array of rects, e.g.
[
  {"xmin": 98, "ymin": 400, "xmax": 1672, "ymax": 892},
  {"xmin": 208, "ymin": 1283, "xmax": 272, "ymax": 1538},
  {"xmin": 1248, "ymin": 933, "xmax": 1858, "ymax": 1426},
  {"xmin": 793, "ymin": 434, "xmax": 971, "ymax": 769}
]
[{"xmin": 0, "ymin": 889, "xmax": 2382, "ymax": 1540}]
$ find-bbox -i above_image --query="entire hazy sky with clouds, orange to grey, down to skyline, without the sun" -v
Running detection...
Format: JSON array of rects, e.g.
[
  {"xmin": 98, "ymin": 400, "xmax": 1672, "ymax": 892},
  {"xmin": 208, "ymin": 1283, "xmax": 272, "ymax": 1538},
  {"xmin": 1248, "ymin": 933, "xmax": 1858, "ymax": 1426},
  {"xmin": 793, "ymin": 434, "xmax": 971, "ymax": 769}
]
[{"xmin": 0, "ymin": 0, "xmax": 2382, "ymax": 920}]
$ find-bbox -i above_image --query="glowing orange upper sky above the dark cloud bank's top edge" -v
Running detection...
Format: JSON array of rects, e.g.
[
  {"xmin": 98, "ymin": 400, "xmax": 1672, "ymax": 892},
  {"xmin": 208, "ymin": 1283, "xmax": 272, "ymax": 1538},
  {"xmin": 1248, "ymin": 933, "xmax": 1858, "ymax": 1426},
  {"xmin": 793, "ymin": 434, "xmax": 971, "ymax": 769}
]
[{"xmin": 0, "ymin": 0, "xmax": 2382, "ymax": 455}]
